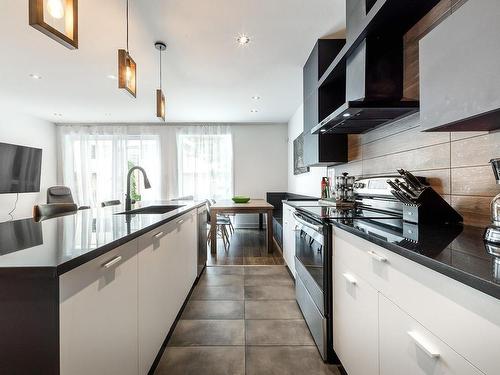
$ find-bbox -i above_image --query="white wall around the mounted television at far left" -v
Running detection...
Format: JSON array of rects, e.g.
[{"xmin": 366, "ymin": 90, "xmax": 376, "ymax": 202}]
[{"xmin": 0, "ymin": 111, "xmax": 57, "ymax": 221}]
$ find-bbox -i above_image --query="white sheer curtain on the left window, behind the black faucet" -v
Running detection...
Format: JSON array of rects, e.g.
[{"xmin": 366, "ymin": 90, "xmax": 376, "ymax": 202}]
[{"xmin": 58, "ymin": 125, "xmax": 162, "ymax": 206}]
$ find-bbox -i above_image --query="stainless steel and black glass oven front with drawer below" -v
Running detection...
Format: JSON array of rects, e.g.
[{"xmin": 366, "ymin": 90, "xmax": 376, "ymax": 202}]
[{"xmin": 294, "ymin": 211, "xmax": 330, "ymax": 361}]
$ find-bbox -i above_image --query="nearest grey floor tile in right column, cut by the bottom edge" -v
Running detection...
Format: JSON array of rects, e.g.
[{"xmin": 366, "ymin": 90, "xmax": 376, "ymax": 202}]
[{"xmin": 246, "ymin": 346, "xmax": 340, "ymax": 375}]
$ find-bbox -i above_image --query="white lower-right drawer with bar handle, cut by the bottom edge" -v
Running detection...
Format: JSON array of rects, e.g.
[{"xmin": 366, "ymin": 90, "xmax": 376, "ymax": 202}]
[{"xmin": 379, "ymin": 295, "xmax": 482, "ymax": 375}]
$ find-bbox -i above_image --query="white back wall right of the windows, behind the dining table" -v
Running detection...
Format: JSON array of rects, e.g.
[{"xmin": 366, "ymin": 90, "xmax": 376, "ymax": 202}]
[{"xmin": 231, "ymin": 124, "xmax": 287, "ymax": 227}]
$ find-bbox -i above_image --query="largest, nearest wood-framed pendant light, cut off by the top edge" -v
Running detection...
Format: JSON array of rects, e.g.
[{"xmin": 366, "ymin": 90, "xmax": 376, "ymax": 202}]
[{"xmin": 29, "ymin": 0, "xmax": 78, "ymax": 49}]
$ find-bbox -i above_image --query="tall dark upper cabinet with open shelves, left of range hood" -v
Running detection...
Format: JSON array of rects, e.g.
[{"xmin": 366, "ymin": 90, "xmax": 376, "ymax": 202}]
[{"xmin": 303, "ymin": 39, "xmax": 347, "ymax": 166}]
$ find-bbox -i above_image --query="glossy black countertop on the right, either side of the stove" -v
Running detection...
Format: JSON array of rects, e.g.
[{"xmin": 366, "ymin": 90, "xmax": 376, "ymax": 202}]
[{"xmin": 287, "ymin": 201, "xmax": 500, "ymax": 299}]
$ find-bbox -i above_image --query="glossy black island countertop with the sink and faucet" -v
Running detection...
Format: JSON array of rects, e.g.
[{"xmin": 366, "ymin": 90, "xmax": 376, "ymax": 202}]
[{"xmin": 0, "ymin": 201, "xmax": 205, "ymax": 275}]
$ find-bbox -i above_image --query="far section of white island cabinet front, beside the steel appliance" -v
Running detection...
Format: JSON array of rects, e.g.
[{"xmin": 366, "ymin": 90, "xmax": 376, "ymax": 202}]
[{"xmin": 138, "ymin": 213, "xmax": 197, "ymax": 374}]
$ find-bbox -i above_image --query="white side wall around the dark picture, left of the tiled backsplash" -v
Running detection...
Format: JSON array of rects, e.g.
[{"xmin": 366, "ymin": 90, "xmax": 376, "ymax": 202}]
[{"xmin": 288, "ymin": 105, "xmax": 327, "ymax": 197}]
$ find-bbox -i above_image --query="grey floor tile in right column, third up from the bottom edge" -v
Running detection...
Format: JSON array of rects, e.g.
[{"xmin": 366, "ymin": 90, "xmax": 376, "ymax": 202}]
[{"xmin": 245, "ymin": 301, "xmax": 302, "ymax": 319}]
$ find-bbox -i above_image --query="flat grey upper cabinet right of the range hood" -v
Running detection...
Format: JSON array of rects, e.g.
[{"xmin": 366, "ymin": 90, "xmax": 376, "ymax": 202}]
[{"xmin": 420, "ymin": 0, "xmax": 500, "ymax": 131}]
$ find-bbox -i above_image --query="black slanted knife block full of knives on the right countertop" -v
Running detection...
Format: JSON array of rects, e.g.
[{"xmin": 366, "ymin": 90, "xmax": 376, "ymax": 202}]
[{"xmin": 387, "ymin": 169, "xmax": 463, "ymax": 224}]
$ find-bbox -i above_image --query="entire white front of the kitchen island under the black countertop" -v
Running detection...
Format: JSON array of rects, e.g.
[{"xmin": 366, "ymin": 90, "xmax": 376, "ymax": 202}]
[{"xmin": 59, "ymin": 209, "xmax": 198, "ymax": 375}]
